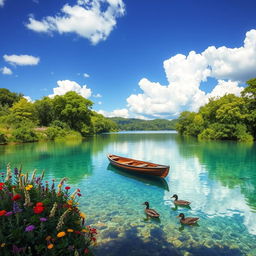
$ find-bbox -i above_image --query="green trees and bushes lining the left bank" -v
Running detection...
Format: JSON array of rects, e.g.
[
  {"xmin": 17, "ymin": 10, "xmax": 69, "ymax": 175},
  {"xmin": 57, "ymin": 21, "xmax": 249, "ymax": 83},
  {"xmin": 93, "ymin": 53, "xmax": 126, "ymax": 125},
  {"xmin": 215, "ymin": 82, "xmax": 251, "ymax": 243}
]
[{"xmin": 0, "ymin": 88, "xmax": 117, "ymax": 144}]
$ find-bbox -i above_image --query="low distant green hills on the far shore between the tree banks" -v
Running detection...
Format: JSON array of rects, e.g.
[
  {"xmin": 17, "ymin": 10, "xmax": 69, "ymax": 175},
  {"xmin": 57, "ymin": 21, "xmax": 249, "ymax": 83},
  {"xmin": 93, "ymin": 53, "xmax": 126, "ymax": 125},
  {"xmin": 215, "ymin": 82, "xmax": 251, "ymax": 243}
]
[{"xmin": 109, "ymin": 117, "xmax": 177, "ymax": 131}]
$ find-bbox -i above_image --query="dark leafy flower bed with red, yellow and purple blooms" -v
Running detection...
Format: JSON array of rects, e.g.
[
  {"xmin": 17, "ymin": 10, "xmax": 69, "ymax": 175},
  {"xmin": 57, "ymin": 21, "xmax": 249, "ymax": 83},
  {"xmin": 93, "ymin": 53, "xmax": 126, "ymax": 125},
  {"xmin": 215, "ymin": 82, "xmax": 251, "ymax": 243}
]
[{"xmin": 0, "ymin": 165, "xmax": 97, "ymax": 256}]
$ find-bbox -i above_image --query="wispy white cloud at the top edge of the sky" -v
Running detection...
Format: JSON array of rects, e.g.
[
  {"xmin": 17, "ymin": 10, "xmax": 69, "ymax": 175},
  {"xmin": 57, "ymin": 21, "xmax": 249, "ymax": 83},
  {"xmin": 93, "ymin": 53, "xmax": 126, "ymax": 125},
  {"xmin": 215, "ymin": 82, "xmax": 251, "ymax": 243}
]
[{"xmin": 26, "ymin": 0, "xmax": 125, "ymax": 44}]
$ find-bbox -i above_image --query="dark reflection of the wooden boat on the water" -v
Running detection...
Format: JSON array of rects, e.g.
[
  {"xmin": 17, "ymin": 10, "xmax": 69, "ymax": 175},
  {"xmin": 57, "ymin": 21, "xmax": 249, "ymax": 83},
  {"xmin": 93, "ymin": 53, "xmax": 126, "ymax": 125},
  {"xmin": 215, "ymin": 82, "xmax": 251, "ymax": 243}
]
[{"xmin": 107, "ymin": 164, "xmax": 169, "ymax": 191}]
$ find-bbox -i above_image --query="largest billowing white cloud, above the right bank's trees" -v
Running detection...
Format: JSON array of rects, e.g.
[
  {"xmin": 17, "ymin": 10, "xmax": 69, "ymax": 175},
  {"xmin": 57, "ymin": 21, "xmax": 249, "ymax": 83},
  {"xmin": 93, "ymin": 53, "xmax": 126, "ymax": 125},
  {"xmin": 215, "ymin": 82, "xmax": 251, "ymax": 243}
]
[{"xmin": 127, "ymin": 30, "xmax": 256, "ymax": 118}]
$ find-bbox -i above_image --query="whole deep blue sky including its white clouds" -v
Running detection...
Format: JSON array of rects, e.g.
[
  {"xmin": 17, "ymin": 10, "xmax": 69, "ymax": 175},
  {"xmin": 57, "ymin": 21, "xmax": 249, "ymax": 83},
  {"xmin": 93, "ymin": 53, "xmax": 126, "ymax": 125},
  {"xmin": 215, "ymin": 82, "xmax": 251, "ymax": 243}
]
[{"xmin": 0, "ymin": 0, "xmax": 256, "ymax": 119}]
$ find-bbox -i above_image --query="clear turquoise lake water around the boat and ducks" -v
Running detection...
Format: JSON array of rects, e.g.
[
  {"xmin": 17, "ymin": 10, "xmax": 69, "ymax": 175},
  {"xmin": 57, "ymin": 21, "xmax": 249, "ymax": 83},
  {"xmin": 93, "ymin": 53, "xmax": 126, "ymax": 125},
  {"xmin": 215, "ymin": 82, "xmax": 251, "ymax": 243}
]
[{"xmin": 0, "ymin": 132, "xmax": 256, "ymax": 256}]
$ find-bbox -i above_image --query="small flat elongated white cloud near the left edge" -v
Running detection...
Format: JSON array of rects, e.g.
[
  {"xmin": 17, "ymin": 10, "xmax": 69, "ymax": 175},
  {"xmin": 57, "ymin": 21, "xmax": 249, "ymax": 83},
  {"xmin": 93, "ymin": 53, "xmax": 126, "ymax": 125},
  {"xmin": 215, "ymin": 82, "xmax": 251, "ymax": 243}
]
[{"xmin": 3, "ymin": 54, "xmax": 40, "ymax": 66}]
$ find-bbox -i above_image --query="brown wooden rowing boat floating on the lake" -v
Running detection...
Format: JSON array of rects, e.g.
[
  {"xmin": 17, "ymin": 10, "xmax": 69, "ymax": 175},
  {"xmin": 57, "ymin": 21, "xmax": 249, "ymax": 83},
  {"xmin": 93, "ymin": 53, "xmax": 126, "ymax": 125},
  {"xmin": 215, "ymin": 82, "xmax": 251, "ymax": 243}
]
[{"xmin": 107, "ymin": 155, "xmax": 170, "ymax": 178}]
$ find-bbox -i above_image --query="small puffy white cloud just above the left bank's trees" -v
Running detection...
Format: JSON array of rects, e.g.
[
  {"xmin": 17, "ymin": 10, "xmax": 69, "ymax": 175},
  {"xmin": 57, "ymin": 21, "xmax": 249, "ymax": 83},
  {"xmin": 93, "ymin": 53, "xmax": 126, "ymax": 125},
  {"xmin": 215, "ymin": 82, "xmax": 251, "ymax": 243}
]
[{"xmin": 49, "ymin": 80, "xmax": 92, "ymax": 99}]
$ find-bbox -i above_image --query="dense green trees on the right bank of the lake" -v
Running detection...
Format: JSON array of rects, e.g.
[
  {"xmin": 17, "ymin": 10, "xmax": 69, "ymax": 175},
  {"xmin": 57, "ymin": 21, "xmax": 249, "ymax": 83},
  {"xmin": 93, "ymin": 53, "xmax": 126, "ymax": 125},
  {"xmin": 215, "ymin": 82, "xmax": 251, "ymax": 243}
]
[{"xmin": 176, "ymin": 78, "xmax": 256, "ymax": 142}]
